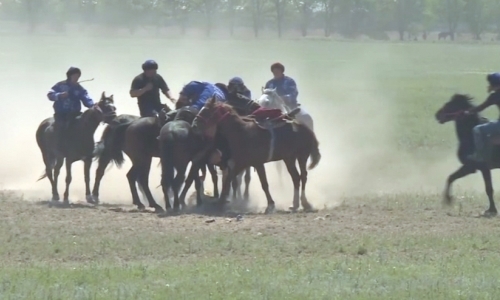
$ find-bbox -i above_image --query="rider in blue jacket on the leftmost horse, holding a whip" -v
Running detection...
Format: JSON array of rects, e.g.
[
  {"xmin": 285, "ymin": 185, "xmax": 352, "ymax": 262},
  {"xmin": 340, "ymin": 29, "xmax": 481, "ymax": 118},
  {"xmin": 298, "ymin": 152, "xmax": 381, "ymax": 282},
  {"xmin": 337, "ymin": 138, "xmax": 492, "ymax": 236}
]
[{"xmin": 47, "ymin": 67, "xmax": 94, "ymax": 152}]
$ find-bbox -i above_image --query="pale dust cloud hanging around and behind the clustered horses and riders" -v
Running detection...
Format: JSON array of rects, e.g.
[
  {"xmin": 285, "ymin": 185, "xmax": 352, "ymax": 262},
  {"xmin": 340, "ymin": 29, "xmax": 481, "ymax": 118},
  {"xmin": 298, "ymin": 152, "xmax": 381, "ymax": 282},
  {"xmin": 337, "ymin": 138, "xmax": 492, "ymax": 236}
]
[{"xmin": 0, "ymin": 35, "xmax": 484, "ymax": 208}]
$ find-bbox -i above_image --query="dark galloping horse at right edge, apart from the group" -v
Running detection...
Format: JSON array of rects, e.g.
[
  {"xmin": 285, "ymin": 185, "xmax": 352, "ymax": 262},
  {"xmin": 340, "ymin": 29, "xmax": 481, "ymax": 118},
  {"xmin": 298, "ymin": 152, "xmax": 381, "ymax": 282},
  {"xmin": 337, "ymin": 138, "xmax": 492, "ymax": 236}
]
[{"xmin": 435, "ymin": 94, "xmax": 500, "ymax": 216}]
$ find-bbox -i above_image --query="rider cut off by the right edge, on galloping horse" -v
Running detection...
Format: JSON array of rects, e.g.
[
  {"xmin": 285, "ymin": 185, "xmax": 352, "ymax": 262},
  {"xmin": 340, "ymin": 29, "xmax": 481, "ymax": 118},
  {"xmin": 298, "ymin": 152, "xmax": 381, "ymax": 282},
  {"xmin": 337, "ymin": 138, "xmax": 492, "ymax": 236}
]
[{"xmin": 466, "ymin": 72, "xmax": 500, "ymax": 161}]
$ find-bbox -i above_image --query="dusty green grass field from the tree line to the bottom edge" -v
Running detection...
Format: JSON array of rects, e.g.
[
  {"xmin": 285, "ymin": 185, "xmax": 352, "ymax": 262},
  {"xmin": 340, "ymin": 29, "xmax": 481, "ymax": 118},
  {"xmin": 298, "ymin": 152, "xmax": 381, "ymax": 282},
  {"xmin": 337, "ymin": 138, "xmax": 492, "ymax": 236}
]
[{"xmin": 0, "ymin": 37, "xmax": 500, "ymax": 300}]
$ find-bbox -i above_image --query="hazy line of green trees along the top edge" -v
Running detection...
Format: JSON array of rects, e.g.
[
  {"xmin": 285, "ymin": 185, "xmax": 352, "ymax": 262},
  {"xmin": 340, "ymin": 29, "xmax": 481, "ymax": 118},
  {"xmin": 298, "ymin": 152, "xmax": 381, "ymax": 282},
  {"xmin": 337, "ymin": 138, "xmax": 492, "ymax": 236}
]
[{"xmin": 0, "ymin": 0, "xmax": 500, "ymax": 40}]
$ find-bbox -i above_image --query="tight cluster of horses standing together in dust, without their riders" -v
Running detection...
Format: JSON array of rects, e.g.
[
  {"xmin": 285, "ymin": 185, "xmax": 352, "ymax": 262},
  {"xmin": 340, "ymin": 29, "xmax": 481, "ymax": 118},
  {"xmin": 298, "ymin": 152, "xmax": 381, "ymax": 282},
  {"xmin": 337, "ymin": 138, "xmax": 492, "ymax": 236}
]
[{"xmin": 36, "ymin": 84, "xmax": 321, "ymax": 213}]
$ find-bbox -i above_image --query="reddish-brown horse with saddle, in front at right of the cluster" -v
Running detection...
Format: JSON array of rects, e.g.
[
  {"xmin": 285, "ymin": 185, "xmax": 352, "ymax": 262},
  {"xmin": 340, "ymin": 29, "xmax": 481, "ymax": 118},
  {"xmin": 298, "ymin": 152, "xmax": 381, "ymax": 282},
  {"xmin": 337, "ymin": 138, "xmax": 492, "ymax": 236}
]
[{"xmin": 192, "ymin": 98, "xmax": 321, "ymax": 213}]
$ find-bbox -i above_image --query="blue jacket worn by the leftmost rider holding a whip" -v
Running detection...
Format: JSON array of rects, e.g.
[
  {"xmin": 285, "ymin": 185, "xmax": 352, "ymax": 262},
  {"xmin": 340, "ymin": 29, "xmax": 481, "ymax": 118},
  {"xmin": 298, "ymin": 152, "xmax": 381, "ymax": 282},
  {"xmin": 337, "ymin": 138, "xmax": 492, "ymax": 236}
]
[{"xmin": 47, "ymin": 80, "xmax": 94, "ymax": 114}]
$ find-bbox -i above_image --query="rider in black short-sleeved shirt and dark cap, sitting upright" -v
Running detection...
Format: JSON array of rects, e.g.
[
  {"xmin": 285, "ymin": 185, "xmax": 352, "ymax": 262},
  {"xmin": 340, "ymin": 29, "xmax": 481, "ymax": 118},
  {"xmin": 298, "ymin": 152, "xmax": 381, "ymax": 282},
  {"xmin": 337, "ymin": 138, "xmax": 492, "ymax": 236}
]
[{"xmin": 130, "ymin": 60, "xmax": 175, "ymax": 117}]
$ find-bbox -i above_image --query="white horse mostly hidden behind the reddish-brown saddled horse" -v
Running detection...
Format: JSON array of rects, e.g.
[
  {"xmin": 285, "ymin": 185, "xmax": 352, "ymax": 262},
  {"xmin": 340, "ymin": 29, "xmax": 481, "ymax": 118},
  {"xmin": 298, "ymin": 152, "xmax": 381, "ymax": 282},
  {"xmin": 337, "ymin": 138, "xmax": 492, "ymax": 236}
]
[{"xmin": 257, "ymin": 88, "xmax": 314, "ymax": 180}]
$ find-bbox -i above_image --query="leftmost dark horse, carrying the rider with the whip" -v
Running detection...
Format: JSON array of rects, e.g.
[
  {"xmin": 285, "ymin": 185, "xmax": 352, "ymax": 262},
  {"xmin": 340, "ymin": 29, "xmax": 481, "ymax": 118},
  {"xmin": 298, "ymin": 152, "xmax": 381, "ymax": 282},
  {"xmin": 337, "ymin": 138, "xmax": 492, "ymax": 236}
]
[{"xmin": 36, "ymin": 92, "xmax": 116, "ymax": 204}]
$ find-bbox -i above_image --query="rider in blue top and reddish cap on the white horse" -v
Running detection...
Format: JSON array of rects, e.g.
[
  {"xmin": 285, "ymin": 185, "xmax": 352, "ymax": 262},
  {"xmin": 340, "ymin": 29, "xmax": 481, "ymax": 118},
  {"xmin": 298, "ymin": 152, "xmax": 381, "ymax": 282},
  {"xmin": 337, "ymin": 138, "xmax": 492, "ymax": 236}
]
[{"xmin": 265, "ymin": 63, "xmax": 299, "ymax": 109}]
